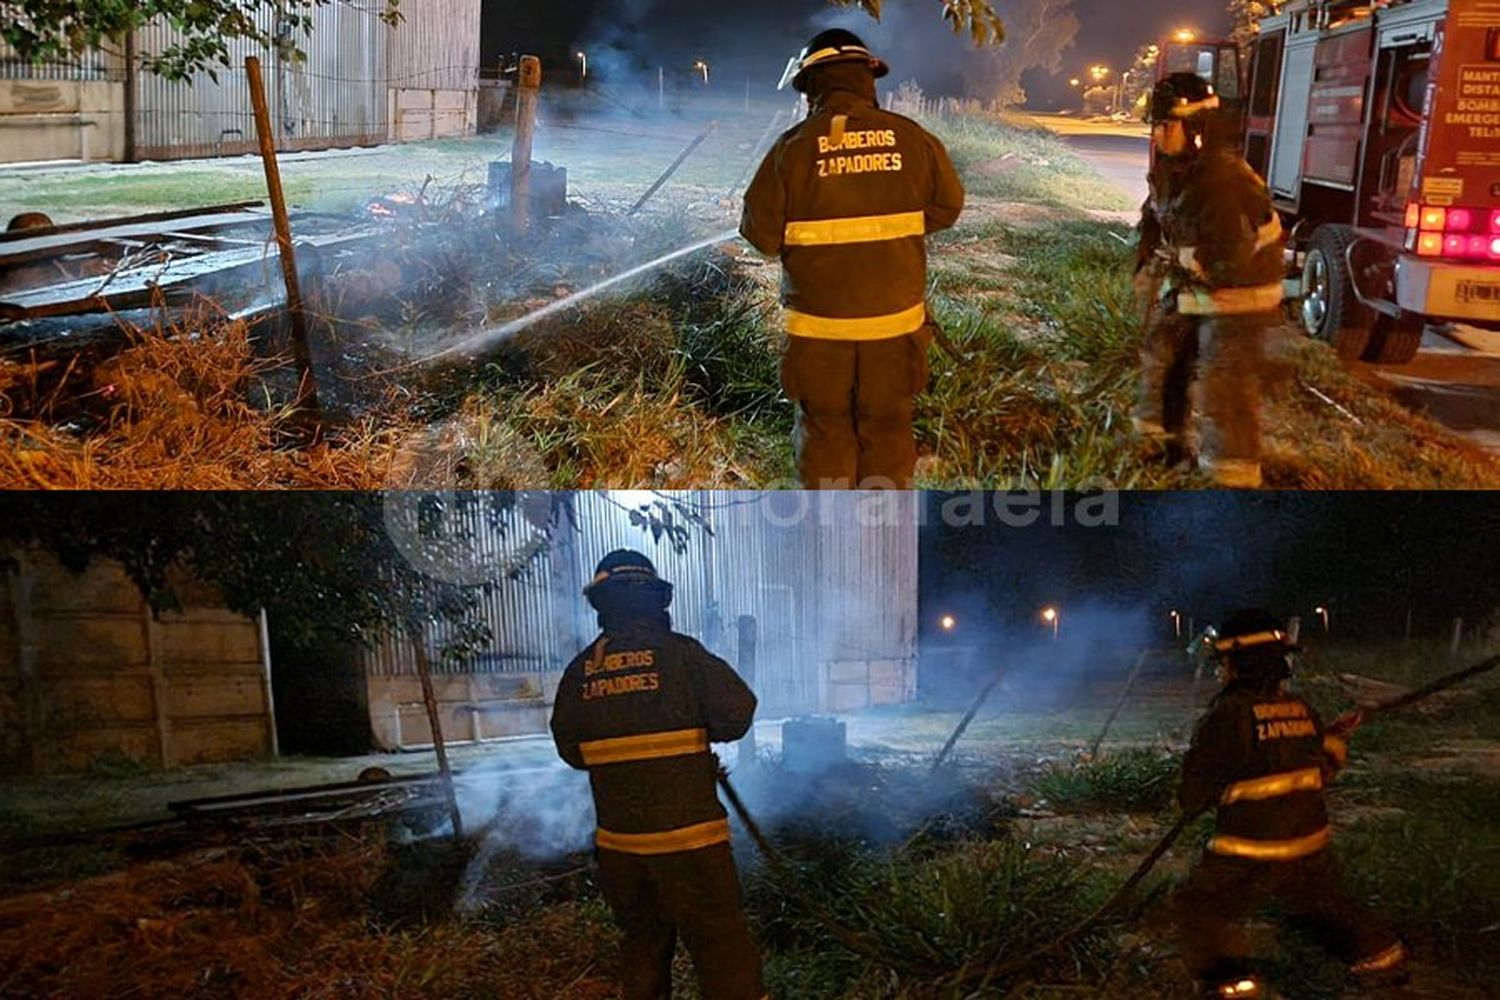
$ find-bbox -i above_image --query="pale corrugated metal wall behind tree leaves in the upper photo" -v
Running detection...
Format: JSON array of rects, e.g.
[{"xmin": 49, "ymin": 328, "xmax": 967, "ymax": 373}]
[{"xmin": 134, "ymin": 1, "xmax": 389, "ymax": 159}]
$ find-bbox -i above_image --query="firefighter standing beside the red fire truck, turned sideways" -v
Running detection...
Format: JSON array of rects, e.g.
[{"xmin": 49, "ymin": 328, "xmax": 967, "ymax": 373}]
[{"xmin": 1136, "ymin": 73, "xmax": 1284, "ymax": 489}]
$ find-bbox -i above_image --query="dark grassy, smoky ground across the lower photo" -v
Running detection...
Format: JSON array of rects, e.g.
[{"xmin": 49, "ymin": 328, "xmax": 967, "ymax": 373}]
[{"xmin": 0, "ymin": 643, "xmax": 1500, "ymax": 1000}]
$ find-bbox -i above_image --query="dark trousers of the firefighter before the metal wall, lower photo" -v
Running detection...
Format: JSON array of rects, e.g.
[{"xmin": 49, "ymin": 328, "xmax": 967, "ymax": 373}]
[{"xmin": 599, "ymin": 844, "xmax": 765, "ymax": 1000}]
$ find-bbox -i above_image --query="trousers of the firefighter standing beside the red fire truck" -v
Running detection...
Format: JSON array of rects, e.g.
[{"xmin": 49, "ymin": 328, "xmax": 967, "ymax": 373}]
[{"xmin": 1136, "ymin": 307, "xmax": 1280, "ymax": 489}]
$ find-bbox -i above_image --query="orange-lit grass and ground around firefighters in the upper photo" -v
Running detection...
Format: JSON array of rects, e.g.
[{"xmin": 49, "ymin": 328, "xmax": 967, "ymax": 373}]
[{"xmin": 0, "ymin": 112, "xmax": 1500, "ymax": 489}]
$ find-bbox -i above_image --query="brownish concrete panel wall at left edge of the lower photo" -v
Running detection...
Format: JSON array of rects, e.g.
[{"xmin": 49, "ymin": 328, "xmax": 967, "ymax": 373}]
[{"xmin": 0, "ymin": 550, "xmax": 276, "ymax": 772}]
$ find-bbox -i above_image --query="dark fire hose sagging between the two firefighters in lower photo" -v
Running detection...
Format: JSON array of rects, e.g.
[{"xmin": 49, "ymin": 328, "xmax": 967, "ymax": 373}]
[{"xmin": 719, "ymin": 655, "xmax": 1500, "ymax": 982}]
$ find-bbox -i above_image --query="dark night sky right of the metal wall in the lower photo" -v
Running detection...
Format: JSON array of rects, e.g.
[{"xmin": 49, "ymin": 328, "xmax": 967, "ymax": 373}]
[{"xmin": 921, "ymin": 492, "xmax": 1500, "ymax": 650}]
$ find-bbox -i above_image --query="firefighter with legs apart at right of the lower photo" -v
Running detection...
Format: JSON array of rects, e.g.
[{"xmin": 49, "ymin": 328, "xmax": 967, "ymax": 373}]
[{"xmin": 1175, "ymin": 610, "xmax": 1406, "ymax": 1000}]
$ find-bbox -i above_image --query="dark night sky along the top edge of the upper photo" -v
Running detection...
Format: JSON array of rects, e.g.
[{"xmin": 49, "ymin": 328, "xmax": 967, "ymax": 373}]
[{"xmin": 485, "ymin": 0, "xmax": 1229, "ymax": 105}]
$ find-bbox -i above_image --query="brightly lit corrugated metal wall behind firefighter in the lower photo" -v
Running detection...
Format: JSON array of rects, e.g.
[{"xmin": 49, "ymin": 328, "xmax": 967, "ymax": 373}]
[{"xmin": 369, "ymin": 492, "xmax": 918, "ymax": 734}]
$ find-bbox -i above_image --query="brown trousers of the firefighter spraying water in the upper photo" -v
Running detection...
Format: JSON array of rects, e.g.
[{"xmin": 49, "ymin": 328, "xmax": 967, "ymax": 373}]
[{"xmin": 782, "ymin": 333, "xmax": 927, "ymax": 489}]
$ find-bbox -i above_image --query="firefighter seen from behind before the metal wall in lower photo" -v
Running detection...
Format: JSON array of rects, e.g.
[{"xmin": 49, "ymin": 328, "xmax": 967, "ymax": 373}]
[{"xmin": 552, "ymin": 550, "xmax": 765, "ymax": 1000}]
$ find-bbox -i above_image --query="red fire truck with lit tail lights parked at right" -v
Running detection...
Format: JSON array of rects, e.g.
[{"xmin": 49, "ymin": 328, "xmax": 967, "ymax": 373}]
[{"xmin": 1163, "ymin": 0, "xmax": 1500, "ymax": 364}]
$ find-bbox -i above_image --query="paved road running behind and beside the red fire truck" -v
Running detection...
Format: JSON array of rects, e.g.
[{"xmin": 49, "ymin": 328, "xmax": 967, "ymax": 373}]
[{"xmin": 1035, "ymin": 115, "xmax": 1500, "ymax": 453}]
